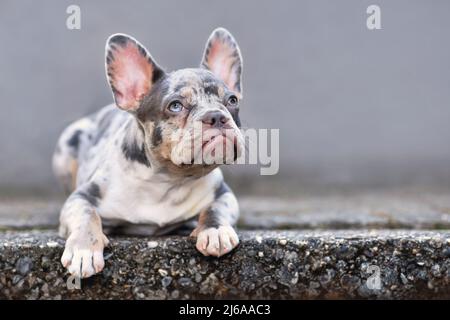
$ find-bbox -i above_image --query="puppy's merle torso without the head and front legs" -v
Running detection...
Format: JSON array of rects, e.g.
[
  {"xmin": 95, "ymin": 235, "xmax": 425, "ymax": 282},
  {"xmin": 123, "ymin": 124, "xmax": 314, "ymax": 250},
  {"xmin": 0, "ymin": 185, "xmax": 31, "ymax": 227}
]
[{"xmin": 54, "ymin": 105, "xmax": 223, "ymax": 227}]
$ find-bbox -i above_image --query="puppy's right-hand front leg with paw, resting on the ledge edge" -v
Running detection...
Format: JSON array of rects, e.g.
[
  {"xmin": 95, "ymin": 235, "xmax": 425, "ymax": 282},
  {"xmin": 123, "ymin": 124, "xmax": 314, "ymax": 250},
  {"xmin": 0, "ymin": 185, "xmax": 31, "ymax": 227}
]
[{"xmin": 191, "ymin": 183, "xmax": 239, "ymax": 257}]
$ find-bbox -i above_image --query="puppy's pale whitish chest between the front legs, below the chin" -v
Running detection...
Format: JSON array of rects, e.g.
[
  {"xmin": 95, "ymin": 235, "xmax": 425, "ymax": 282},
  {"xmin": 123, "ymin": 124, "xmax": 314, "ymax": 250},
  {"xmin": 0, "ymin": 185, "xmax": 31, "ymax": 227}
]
[{"xmin": 98, "ymin": 169, "xmax": 222, "ymax": 227}]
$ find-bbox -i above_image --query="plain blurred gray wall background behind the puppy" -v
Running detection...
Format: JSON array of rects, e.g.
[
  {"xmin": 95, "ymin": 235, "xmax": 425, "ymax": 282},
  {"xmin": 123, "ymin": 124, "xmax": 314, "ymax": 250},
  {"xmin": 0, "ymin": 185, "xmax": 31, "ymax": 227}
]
[{"xmin": 0, "ymin": 0, "xmax": 450, "ymax": 194}]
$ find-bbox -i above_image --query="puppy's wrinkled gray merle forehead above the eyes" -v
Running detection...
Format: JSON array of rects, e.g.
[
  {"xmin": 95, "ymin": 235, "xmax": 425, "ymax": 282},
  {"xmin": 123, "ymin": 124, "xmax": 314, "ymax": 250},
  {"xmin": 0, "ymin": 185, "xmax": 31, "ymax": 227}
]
[{"xmin": 167, "ymin": 69, "xmax": 228, "ymax": 105}]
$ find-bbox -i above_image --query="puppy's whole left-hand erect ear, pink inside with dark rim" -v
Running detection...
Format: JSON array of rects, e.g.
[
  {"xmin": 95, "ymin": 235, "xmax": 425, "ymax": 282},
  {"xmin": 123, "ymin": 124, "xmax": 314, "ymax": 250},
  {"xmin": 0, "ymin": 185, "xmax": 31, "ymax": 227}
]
[{"xmin": 106, "ymin": 34, "xmax": 164, "ymax": 111}]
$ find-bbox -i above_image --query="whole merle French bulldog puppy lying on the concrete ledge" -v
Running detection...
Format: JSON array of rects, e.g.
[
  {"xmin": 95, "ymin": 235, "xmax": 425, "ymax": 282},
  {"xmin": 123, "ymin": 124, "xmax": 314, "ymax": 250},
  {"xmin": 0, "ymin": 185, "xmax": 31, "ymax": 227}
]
[{"xmin": 53, "ymin": 28, "xmax": 243, "ymax": 277}]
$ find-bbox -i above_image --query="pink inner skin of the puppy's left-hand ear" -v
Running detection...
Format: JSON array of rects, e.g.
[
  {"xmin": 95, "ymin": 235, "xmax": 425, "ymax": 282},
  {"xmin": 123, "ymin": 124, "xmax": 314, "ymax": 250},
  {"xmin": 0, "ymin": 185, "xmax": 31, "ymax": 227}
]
[{"xmin": 108, "ymin": 40, "xmax": 154, "ymax": 110}]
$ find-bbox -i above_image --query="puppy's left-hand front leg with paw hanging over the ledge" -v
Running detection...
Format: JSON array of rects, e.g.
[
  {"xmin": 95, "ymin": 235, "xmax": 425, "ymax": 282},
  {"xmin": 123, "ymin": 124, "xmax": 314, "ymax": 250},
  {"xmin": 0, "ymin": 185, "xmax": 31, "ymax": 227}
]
[{"xmin": 60, "ymin": 188, "xmax": 108, "ymax": 278}]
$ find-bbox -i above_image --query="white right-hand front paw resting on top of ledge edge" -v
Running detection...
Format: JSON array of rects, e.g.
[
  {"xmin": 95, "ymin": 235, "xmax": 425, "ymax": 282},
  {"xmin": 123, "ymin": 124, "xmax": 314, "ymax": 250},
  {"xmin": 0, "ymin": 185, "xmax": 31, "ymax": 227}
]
[{"xmin": 193, "ymin": 226, "xmax": 239, "ymax": 257}]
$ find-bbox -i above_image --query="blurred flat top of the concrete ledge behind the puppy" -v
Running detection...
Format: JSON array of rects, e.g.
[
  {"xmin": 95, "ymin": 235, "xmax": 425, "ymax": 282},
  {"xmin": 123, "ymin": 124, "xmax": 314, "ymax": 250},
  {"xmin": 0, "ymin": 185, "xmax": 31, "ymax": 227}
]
[{"xmin": 0, "ymin": 190, "xmax": 450, "ymax": 230}]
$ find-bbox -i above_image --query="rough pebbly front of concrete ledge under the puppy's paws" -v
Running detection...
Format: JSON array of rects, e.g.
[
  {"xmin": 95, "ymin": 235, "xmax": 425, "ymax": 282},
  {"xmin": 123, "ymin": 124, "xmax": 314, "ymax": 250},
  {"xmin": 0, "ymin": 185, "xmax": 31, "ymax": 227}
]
[{"xmin": 0, "ymin": 230, "xmax": 450, "ymax": 299}]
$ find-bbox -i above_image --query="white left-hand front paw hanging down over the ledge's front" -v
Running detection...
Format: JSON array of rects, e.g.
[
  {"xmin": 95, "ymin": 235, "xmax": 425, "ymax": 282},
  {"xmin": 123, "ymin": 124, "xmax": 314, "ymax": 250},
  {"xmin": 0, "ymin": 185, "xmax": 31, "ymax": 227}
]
[{"xmin": 61, "ymin": 233, "xmax": 109, "ymax": 278}]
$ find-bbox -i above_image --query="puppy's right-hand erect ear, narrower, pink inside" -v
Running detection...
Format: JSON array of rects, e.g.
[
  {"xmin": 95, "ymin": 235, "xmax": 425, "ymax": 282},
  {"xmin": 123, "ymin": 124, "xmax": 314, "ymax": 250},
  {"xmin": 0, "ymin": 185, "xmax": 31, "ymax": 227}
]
[{"xmin": 201, "ymin": 28, "xmax": 242, "ymax": 95}]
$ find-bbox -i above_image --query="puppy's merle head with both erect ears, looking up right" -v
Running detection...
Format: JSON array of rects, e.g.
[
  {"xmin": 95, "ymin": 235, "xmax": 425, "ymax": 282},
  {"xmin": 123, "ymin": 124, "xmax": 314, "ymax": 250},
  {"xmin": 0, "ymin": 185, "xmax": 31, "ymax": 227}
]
[{"xmin": 106, "ymin": 28, "xmax": 243, "ymax": 175}]
